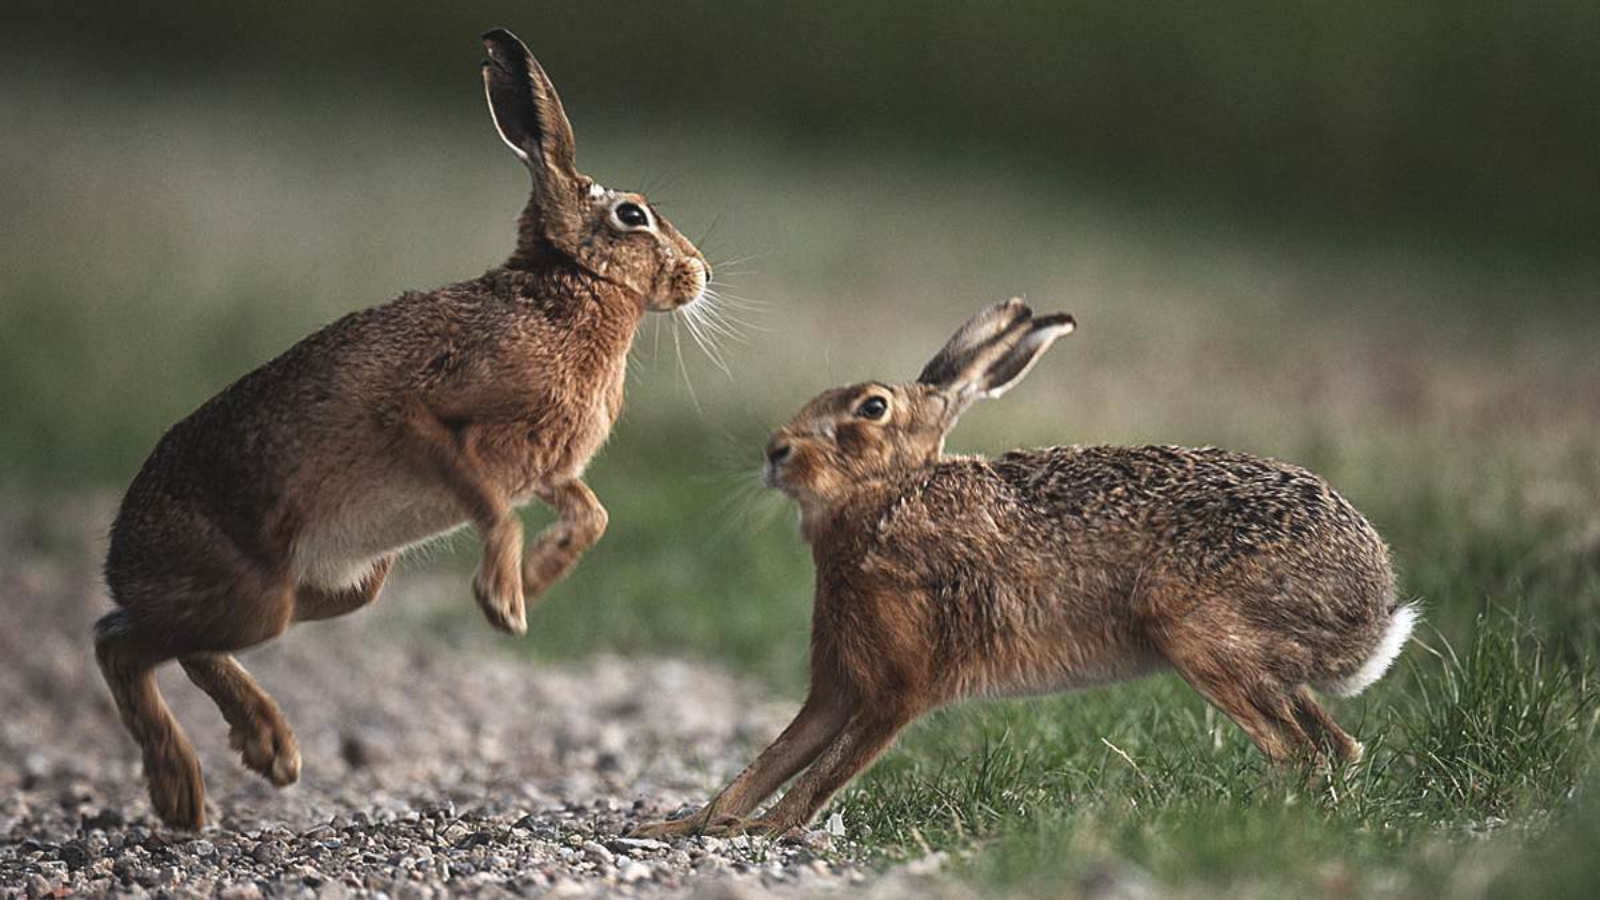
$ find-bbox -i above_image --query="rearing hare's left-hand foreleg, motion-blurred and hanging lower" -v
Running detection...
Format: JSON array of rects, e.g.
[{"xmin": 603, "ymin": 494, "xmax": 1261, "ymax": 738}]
[{"xmin": 402, "ymin": 400, "xmax": 528, "ymax": 634}]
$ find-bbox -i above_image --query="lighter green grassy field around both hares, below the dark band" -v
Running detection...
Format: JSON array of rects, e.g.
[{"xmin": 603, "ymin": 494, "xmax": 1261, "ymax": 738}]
[{"xmin": 12, "ymin": 83, "xmax": 1600, "ymax": 897}]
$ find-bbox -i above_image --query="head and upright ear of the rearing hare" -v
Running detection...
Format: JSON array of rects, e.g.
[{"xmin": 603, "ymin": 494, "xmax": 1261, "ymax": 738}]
[{"xmin": 483, "ymin": 29, "xmax": 710, "ymax": 311}]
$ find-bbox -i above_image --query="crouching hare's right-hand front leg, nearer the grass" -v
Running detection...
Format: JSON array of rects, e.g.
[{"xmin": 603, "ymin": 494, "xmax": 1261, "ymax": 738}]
[{"xmin": 706, "ymin": 703, "xmax": 920, "ymax": 836}]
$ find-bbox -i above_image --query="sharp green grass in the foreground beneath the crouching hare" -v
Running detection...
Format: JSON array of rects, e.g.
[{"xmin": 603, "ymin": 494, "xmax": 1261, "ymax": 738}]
[{"xmin": 835, "ymin": 613, "xmax": 1600, "ymax": 895}]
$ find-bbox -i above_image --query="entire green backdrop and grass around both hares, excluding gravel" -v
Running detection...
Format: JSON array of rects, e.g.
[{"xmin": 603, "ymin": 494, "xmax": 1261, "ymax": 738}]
[{"xmin": 0, "ymin": 0, "xmax": 1600, "ymax": 886}]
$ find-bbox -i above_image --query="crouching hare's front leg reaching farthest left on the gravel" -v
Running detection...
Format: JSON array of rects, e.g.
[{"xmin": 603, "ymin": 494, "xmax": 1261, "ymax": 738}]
[{"xmin": 630, "ymin": 690, "xmax": 850, "ymax": 838}]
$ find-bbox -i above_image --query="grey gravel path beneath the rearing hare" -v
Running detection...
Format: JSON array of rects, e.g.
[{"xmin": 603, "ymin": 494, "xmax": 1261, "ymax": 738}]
[{"xmin": 0, "ymin": 501, "xmax": 955, "ymax": 898}]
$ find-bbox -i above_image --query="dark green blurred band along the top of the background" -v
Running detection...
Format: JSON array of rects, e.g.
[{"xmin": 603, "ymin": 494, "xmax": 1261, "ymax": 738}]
[{"xmin": 9, "ymin": 0, "xmax": 1600, "ymax": 253}]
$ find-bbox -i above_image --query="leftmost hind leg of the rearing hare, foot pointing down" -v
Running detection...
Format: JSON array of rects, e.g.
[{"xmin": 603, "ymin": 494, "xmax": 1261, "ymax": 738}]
[{"xmin": 94, "ymin": 610, "xmax": 205, "ymax": 831}]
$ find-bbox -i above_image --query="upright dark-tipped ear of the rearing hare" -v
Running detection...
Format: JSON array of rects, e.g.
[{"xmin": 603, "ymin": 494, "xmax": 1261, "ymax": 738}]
[{"xmin": 483, "ymin": 29, "xmax": 584, "ymax": 230}]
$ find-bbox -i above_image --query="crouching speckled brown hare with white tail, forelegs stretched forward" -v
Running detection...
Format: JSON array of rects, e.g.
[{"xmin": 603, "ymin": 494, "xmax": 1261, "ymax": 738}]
[{"xmin": 637, "ymin": 299, "xmax": 1416, "ymax": 836}]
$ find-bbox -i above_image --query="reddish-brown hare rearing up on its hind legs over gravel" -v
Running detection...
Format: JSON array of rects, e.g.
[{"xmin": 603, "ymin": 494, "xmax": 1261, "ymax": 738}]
[{"xmin": 94, "ymin": 30, "xmax": 710, "ymax": 828}]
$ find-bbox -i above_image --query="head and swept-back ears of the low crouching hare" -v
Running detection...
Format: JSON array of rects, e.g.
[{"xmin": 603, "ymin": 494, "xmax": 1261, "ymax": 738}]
[{"xmin": 765, "ymin": 298, "xmax": 1074, "ymax": 509}]
